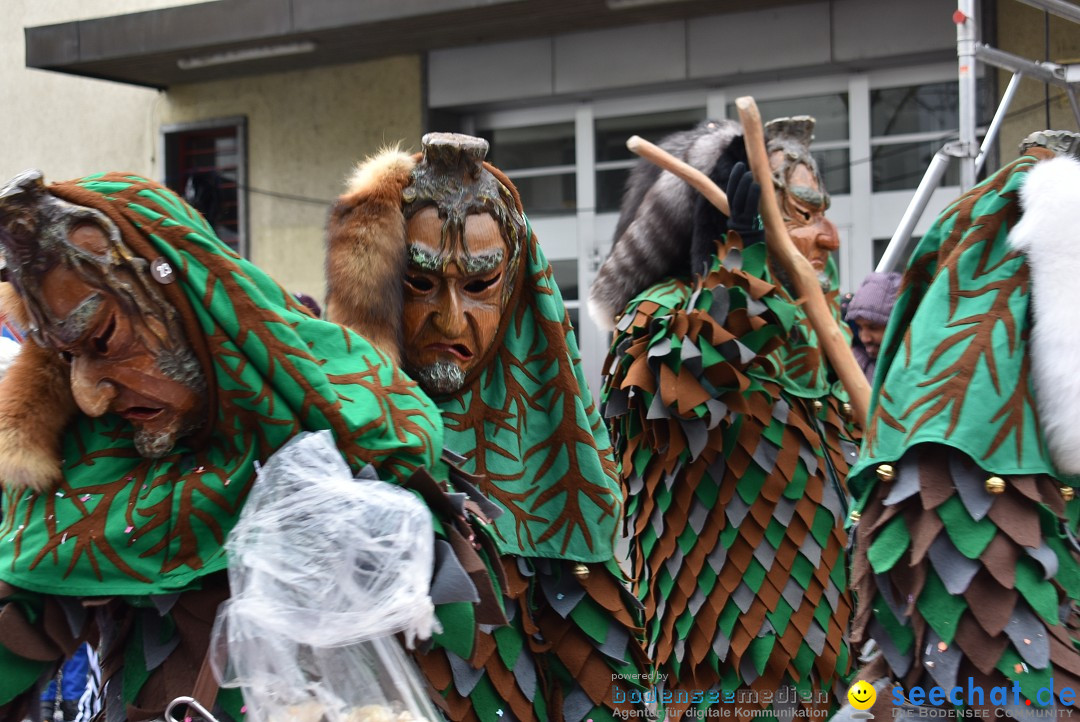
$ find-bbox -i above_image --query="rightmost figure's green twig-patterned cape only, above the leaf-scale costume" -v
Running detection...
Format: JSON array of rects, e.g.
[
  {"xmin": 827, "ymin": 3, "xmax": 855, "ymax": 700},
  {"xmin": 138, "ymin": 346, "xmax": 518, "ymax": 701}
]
[{"xmin": 851, "ymin": 156, "xmax": 1053, "ymax": 487}]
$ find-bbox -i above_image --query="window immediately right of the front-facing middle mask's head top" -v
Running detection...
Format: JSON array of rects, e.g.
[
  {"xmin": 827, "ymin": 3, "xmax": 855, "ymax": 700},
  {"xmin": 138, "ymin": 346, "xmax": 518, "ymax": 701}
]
[{"xmin": 477, "ymin": 122, "xmax": 578, "ymax": 216}]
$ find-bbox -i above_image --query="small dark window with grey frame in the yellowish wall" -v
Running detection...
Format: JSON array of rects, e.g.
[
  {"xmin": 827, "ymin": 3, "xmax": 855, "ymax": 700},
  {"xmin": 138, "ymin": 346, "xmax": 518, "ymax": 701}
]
[{"xmin": 164, "ymin": 124, "xmax": 245, "ymax": 253}]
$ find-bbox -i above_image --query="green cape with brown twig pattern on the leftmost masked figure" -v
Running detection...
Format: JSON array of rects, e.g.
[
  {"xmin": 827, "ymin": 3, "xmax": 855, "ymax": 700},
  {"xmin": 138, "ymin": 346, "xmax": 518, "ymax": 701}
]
[{"xmin": 0, "ymin": 174, "xmax": 443, "ymax": 713}]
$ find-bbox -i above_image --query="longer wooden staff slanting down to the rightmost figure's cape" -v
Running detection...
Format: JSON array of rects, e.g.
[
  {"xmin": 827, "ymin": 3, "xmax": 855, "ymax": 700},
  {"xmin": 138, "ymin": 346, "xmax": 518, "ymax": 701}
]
[{"xmin": 735, "ymin": 95, "xmax": 870, "ymax": 423}]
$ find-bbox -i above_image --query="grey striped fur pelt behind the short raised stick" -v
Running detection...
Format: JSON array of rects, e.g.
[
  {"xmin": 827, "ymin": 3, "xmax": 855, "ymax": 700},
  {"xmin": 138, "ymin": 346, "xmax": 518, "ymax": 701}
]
[{"xmin": 589, "ymin": 120, "xmax": 742, "ymax": 330}]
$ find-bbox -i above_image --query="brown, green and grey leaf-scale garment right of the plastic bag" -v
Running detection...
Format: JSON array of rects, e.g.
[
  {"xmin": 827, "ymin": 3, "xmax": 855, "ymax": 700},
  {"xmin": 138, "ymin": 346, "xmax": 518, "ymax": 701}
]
[{"xmin": 409, "ymin": 465, "xmax": 649, "ymax": 722}]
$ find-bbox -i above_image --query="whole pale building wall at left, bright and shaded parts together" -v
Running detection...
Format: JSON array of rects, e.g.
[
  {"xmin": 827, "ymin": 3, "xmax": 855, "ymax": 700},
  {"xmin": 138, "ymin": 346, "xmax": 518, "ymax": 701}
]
[{"xmin": 6, "ymin": 0, "xmax": 423, "ymax": 301}]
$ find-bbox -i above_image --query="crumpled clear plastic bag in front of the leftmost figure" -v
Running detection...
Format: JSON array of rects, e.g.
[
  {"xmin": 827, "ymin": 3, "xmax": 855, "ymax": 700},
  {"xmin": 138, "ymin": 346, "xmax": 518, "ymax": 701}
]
[{"xmin": 213, "ymin": 432, "xmax": 442, "ymax": 722}]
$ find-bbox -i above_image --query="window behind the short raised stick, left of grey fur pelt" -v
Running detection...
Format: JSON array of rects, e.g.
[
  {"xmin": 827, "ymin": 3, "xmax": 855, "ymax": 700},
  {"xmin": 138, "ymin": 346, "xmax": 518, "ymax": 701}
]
[{"xmin": 595, "ymin": 108, "xmax": 705, "ymax": 213}]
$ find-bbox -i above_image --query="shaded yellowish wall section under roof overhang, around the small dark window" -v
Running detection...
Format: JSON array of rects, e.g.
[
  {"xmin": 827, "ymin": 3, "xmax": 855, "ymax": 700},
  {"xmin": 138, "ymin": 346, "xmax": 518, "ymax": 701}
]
[{"xmin": 157, "ymin": 56, "xmax": 422, "ymax": 302}]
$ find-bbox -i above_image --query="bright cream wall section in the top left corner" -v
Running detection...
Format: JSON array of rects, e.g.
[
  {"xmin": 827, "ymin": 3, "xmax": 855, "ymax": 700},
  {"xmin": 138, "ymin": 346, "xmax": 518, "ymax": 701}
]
[{"xmin": 0, "ymin": 0, "xmax": 206, "ymax": 182}]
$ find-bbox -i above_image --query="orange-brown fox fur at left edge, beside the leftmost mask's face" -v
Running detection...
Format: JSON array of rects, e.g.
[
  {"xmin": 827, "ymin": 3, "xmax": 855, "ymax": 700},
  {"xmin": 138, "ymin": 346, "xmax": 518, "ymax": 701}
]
[{"xmin": 0, "ymin": 284, "xmax": 78, "ymax": 492}]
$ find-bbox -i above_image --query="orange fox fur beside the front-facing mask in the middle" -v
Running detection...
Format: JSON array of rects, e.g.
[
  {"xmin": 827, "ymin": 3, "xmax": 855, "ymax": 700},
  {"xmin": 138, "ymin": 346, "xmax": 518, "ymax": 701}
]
[{"xmin": 326, "ymin": 149, "xmax": 416, "ymax": 363}]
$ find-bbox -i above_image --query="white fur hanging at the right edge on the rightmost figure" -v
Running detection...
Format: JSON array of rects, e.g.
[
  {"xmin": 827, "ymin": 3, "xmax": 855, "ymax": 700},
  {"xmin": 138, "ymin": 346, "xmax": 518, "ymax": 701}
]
[{"xmin": 1009, "ymin": 155, "xmax": 1080, "ymax": 474}]
